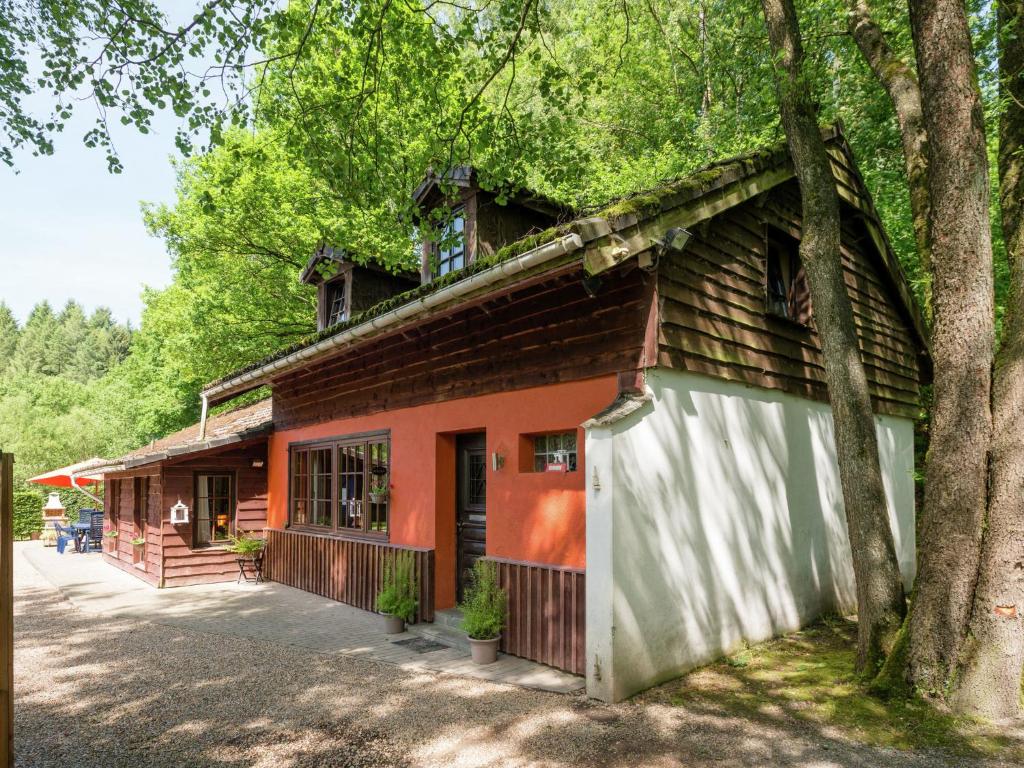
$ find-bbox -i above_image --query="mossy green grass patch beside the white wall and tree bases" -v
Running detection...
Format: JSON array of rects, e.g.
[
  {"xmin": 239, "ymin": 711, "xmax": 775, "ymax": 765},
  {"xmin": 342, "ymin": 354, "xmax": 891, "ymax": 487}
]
[{"xmin": 641, "ymin": 620, "xmax": 1024, "ymax": 762}]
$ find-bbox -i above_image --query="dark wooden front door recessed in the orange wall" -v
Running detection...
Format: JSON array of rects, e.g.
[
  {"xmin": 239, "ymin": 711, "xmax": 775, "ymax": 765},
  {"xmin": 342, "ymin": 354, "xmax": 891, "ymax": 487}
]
[{"xmin": 455, "ymin": 432, "xmax": 487, "ymax": 601}]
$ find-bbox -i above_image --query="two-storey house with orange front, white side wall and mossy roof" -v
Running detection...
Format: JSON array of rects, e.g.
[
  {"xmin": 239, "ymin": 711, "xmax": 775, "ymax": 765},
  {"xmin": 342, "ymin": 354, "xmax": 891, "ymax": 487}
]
[{"xmin": 101, "ymin": 129, "xmax": 928, "ymax": 700}]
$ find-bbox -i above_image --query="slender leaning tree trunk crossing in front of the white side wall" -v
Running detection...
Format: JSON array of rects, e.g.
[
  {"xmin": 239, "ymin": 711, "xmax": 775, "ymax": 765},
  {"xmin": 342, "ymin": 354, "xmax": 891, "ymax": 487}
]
[{"xmin": 761, "ymin": 0, "xmax": 905, "ymax": 669}]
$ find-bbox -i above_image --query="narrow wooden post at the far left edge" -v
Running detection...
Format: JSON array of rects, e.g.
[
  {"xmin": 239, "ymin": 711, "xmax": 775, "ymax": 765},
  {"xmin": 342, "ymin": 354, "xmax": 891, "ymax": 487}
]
[{"xmin": 0, "ymin": 453, "xmax": 14, "ymax": 768}]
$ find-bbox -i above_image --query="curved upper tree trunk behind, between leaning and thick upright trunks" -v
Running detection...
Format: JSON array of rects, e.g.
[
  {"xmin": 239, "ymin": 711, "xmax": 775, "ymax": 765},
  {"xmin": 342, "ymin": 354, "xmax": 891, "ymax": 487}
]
[{"xmin": 847, "ymin": 0, "xmax": 932, "ymax": 315}]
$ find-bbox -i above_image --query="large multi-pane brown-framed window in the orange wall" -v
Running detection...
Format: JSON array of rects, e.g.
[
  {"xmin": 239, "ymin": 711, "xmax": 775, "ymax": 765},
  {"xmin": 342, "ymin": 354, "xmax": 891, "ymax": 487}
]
[{"xmin": 290, "ymin": 432, "xmax": 391, "ymax": 536}]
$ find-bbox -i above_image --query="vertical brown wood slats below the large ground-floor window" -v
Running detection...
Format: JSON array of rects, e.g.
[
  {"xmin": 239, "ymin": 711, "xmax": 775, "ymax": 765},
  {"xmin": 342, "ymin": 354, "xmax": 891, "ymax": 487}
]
[{"xmin": 263, "ymin": 528, "xmax": 434, "ymax": 622}]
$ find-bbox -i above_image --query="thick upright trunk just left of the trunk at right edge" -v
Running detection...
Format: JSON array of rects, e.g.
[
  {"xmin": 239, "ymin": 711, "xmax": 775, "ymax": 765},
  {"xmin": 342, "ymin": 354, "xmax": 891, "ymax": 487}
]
[{"xmin": 908, "ymin": 0, "xmax": 994, "ymax": 693}]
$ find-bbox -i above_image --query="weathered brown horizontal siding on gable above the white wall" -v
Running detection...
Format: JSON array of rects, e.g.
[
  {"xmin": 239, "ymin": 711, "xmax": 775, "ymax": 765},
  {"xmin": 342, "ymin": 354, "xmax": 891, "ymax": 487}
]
[{"xmin": 658, "ymin": 181, "xmax": 922, "ymax": 417}]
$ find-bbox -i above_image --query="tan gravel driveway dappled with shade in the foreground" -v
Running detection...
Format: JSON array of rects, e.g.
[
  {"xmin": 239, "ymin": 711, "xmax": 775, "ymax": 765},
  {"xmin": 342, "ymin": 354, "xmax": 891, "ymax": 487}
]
[{"xmin": 14, "ymin": 558, "xmax": 999, "ymax": 768}]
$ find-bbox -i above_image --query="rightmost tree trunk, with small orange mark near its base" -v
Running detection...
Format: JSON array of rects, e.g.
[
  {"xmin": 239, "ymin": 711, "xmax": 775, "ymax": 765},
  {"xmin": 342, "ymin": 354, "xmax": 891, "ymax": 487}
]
[{"xmin": 952, "ymin": 0, "xmax": 1024, "ymax": 719}]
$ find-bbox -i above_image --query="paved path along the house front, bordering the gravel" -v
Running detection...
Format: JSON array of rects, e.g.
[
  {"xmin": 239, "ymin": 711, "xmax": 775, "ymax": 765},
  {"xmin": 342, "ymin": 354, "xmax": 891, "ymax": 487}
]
[{"xmin": 18, "ymin": 542, "xmax": 584, "ymax": 693}]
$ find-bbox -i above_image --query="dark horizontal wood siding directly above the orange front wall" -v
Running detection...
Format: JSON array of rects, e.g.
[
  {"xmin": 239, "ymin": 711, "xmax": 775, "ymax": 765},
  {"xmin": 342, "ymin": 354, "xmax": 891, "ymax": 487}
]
[{"xmin": 273, "ymin": 265, "xmax": 653, "ymax": 429}]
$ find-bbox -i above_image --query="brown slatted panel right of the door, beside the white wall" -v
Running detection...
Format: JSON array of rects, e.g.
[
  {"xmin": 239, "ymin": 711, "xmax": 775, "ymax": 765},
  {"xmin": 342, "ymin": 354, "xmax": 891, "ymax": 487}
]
[{"xmin": 487, "ymin": 557, "xmax": 587, "ymax": 675}]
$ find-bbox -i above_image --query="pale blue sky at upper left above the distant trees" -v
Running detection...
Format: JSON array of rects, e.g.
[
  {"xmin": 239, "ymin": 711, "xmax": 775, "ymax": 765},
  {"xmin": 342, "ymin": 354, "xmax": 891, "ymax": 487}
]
[{"xmin": 0, "ymin": 88, "xmax": 177, "ymax": 327}]
